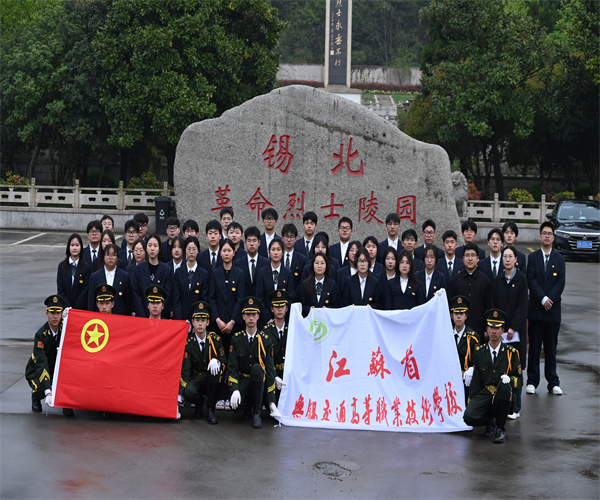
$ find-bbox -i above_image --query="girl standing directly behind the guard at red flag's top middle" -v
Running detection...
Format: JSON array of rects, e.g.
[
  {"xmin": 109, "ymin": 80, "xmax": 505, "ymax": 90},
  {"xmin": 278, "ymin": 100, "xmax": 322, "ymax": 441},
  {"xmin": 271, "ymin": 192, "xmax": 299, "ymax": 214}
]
[{"xmin": 130, "ymin": 234, "xmax": 173, "ymax": 319}]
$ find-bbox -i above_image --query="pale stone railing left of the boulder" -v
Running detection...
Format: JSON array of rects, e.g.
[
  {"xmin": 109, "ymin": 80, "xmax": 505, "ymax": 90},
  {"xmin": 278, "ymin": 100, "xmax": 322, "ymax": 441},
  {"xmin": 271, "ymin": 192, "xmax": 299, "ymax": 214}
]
[{"xmin": 0, "ymin": 178, "xmax": 174, "ymax": 212}]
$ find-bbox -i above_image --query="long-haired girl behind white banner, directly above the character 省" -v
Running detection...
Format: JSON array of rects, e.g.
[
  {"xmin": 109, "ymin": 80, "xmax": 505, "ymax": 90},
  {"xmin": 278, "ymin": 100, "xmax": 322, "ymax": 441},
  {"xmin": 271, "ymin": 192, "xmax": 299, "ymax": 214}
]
[{"xmin": 383, "ymin": 250, "xmax": 425, "ymax": 311}]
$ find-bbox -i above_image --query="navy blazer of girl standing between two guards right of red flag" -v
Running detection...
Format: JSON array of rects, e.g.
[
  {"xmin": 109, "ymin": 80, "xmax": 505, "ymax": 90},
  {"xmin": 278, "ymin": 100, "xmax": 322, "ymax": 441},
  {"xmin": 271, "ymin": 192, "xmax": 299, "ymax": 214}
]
[{"xmin": 208, "ymin": 266, "xmax": 246, "ymax": 323}]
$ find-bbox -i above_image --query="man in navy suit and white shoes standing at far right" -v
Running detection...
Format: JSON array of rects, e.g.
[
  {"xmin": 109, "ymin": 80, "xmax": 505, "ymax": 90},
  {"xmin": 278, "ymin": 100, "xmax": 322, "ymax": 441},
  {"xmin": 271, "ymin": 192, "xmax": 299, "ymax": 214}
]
[{"xmin": 526, "ymin": 222, "xmax": 566, "ymax": 396}]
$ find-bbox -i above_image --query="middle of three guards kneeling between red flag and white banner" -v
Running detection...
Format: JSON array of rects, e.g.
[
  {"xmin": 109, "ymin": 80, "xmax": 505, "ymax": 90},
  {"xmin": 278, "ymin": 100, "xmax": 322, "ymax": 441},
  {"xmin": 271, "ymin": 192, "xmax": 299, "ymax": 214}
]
[{"xmin": 228, "ymin": 297, "xmax": 281, "ymax": 429}]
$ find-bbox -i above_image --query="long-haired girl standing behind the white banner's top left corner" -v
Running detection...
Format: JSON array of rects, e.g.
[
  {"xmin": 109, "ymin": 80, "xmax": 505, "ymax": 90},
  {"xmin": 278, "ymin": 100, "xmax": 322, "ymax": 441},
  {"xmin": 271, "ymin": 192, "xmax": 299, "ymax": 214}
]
[{"xmin": 295, "ymin": 252, "xmax": 341, "ymax": 318}]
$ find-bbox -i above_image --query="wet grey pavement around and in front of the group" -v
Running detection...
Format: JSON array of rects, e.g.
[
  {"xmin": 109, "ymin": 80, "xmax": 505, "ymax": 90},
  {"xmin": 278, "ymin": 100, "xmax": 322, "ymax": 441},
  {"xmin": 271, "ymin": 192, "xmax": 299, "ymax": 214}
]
[{"xmin": 0, "ymin": 231, "xmax": 600, "ymax": 499}]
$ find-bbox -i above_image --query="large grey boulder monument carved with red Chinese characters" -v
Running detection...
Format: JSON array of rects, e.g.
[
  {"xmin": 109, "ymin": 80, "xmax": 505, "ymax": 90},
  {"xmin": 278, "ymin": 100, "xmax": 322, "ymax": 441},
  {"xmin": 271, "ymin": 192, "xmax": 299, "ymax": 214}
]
[{"xmin": 175, "ymin": 85, "xmax": 460, "ymax": 243}]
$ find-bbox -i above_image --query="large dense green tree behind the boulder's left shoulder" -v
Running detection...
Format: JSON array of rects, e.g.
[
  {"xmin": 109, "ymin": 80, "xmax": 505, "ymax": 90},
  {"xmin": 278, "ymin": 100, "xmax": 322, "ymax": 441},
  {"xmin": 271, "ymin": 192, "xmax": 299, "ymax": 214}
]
[{"xmin": 95, "ymin": 0, "xmax": 285, "ymax": 188}]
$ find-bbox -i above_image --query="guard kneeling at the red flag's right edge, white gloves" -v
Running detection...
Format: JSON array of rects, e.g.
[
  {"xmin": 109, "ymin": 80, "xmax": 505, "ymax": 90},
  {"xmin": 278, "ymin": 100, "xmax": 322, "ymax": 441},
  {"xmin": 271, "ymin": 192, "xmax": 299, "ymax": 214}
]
[{"xmin": 179, "ymin": 301, "xmax": 226, "ymax": 424}]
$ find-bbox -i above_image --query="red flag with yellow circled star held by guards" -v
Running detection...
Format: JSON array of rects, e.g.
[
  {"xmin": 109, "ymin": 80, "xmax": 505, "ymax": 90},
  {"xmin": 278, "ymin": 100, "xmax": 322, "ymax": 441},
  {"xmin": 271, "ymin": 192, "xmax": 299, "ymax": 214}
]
[{"xmin": 52, "ymin": 309, "xmax": 188, "ymax": 418}]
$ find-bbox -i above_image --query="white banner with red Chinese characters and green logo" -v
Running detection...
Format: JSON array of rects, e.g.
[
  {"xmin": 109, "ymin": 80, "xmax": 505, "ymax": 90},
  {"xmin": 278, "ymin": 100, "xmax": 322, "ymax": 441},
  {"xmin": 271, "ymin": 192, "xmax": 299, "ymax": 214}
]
[{"xmin": 279, "ymin": 291, "xmax": 471, "ymax": 432}]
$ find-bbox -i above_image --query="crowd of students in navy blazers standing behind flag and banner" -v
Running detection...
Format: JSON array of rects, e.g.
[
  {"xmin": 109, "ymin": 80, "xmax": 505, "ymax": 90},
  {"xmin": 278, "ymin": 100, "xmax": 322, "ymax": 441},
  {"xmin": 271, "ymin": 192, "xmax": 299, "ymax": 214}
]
[{"xmin": 30, "ymin": 208, "xmax": 565, "ymax": 440}]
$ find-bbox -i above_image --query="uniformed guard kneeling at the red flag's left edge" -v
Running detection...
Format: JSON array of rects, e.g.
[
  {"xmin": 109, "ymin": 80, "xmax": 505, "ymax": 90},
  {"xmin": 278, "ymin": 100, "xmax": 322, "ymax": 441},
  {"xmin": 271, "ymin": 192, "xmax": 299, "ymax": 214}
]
[{"xmin": 25, "ymin": 295, "xmax": 73, "ymax": 417}]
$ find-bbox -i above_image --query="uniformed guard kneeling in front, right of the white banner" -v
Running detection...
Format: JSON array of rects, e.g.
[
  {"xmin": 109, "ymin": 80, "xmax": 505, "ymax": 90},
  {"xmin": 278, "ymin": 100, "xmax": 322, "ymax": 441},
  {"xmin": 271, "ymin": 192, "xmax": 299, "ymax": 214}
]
[{"xmin": 464, "ymin": 309, "xmax": 523, "ymax": 443}]
